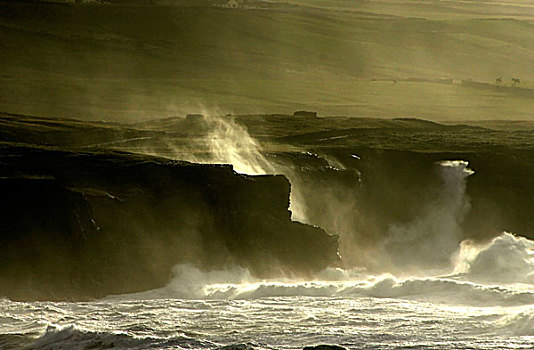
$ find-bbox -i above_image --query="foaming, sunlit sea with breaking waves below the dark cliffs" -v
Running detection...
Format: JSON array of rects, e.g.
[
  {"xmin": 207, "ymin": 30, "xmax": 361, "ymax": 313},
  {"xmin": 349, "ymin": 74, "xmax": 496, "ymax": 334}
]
[{"xmin": 0, "ymin": 233, "xmax": 534, "ymax": 350}]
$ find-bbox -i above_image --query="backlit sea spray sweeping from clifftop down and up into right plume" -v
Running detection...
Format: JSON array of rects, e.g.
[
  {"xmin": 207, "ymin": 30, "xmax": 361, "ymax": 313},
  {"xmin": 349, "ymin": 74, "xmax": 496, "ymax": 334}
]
[{"xmin": 147, "ymin": 116, "xmax": 486, "ymax": 275}]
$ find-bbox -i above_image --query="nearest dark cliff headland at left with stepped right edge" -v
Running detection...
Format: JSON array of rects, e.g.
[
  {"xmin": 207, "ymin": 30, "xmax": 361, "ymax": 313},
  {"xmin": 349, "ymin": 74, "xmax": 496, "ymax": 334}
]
[{"xmin": 0, "ymin": 147, "xmax": 338, "ymax": 299}]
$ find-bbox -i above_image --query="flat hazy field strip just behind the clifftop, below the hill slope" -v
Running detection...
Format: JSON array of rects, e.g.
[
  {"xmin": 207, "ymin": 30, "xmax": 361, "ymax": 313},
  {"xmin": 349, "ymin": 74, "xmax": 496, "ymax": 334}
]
[{"xmin": 0, "ymin": 77, "xmax": 534, "ymax": 121}]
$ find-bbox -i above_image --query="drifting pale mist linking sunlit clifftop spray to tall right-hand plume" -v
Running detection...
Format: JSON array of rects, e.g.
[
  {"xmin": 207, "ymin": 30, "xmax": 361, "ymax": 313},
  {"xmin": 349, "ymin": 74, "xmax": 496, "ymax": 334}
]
[{"xmin": 140, "ymin": 109, "xmax": 520, "ymax": 284}]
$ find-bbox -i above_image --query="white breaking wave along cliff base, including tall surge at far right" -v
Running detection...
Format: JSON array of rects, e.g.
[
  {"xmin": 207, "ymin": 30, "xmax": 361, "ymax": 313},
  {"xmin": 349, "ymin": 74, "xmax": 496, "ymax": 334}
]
[{"xmin": 116, "ymin": 233, "xmax": 534, "ymax": 305}]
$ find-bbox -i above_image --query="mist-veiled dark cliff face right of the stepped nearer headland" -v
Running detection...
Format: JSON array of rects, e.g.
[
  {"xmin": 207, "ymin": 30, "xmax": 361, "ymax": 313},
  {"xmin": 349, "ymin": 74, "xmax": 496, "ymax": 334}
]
[{"xmin": 276, "ymin": 146, "xmax": 534, "ymax": 271}]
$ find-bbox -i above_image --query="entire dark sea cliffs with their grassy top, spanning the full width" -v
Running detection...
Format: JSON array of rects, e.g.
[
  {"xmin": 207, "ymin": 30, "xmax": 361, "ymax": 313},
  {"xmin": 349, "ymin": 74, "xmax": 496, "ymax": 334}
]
[{"xmin": 0, "ymin": 114, "xmax": 534, "ymax": 299}]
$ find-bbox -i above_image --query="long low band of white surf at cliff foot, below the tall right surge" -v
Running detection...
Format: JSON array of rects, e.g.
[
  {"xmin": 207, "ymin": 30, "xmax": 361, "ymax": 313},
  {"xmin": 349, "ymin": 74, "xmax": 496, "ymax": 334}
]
[{"xmin": 113, "ymin": 265, "xmax": 534, "ymax": 305}]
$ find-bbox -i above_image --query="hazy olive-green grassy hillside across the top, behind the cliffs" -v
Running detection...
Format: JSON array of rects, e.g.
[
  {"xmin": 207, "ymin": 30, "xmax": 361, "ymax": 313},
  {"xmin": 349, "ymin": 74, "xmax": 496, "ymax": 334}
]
[{"xmin": 0, "ymin": 0, "xmax": 534, "ymax": 121}]
